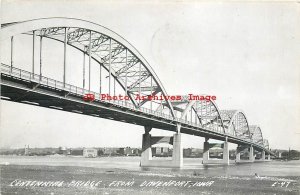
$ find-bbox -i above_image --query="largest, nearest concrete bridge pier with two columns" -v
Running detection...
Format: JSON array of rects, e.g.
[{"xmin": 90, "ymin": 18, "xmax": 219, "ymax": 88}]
[{"xmin": 140, "ymin": 125, "xmax": 183, "ymax": 168}]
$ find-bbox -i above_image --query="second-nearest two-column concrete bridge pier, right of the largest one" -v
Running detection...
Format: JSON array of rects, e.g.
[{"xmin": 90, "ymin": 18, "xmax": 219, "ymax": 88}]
[{"xmin": 202, "ymin": 138, "xmax": 229, "ymax": 165}]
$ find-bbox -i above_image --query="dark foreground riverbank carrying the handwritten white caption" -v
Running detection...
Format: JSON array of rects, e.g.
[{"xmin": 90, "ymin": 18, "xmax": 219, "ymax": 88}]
[{"xmin": 0, "ymin": 165, "xmax": 300, "ymax": 195}]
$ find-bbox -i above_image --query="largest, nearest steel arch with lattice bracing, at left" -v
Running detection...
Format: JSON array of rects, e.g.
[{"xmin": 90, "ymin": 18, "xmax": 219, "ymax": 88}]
[{"xmin": 1, "ymin": 17, "xmax": 175, "ymax": 118}]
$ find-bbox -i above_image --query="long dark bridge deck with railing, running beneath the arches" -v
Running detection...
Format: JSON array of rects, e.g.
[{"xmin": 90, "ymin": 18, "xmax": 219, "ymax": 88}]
[{"xmin": 1, "ymin": 64, "xmax": 271, "ymax": 153}]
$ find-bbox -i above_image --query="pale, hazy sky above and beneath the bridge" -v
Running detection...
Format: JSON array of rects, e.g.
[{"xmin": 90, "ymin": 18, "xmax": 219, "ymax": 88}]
[{"xmin": 0, "ymin": 0, "xmax": 300, "ymax": 150}]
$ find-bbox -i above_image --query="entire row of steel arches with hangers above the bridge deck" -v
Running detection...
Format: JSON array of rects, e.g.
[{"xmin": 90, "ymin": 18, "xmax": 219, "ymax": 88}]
[{"xmin": 1, "ymin": 18, "xmax": 269, "ymax": 152}]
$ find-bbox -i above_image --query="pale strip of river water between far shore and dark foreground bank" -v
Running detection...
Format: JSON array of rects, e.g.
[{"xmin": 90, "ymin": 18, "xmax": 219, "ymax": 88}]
[{"xmin": 0, "ymin": 156, "xmax": 300, "ymax": 176}]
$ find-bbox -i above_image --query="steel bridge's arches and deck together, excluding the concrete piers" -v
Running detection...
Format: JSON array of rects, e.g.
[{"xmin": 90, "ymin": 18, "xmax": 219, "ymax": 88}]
[{"xmin": 1, "ymin": 18, "xmax": 272, "ymax": 154}]
